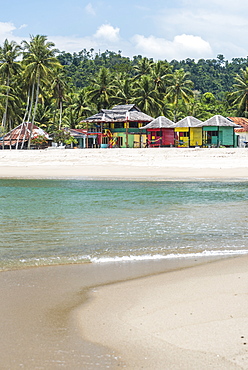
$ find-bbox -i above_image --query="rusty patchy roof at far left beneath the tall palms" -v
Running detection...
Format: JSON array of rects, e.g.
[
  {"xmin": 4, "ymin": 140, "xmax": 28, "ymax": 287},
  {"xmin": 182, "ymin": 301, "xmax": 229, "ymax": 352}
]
[{"xmin": 0, "ymin": 122, "xmax": 51, "ymax": 145}]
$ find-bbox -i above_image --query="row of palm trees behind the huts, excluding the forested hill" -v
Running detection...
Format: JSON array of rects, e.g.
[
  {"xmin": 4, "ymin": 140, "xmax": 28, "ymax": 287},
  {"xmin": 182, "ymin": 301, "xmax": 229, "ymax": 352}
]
[{"xmin": 0, "ymin": 35, "xmax": 248, "ymax": 146}]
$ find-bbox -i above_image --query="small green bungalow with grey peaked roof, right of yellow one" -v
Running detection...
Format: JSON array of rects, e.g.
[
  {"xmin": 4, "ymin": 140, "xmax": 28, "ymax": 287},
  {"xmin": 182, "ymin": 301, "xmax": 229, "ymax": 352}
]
[{"xmin": 202, "ymin": 115, "xmax": 240, "ymax": 147}]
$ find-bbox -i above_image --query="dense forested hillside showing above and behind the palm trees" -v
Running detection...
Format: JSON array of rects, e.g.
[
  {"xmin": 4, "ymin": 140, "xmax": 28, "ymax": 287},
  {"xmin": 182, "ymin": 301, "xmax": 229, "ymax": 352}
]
[{"xmin": 58, "ymin": 49, "xmax": 248, "ymax": 99}]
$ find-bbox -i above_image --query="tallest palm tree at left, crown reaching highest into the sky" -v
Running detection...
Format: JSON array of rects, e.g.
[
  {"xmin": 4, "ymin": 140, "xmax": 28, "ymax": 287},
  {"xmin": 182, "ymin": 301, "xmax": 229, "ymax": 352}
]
[{"xmin": 23, "ymin": 35, "xmax": 61, "ymax": 148}]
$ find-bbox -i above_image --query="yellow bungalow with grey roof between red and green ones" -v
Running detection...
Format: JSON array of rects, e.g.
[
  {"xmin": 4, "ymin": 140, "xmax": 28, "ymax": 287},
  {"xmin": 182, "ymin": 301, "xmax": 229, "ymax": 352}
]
[{"xmin": 174, "ymin": 116, "xmax": 202, "ymax": 147}]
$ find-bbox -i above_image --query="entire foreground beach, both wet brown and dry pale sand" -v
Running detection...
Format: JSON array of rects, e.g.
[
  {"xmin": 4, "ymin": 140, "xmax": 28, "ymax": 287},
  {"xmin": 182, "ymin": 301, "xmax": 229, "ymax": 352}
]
[{"xmin": 0, "ymin": 256, "xmax": 248, "ymax": 370}]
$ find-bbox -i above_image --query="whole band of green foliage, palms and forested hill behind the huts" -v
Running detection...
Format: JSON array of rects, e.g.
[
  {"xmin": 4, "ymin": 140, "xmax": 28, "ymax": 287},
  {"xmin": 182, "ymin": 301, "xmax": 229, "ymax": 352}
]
[{"xmin": 0, "ymin": 35, "xmax": 248, "ymax": 136}]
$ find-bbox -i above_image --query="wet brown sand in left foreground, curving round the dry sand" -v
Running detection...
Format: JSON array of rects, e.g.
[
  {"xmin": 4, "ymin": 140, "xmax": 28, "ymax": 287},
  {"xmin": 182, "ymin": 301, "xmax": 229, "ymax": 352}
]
[{"xmin": 0, "ymin": 258, "xmax": 220, "ymax": 369}]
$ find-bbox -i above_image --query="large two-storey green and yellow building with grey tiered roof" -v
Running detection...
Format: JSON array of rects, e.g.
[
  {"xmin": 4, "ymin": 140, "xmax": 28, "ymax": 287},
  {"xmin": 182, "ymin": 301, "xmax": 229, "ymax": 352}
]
[{"xmin": 82, "ymin": 104, "xmax": 153, "ymax": 148}]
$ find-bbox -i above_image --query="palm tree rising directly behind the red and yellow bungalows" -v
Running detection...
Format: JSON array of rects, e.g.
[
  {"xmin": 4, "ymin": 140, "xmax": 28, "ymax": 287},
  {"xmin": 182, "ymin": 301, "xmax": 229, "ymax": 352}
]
[{"xmin": 166, "ymin": 68, "xmax": 194, "ymax": 121}]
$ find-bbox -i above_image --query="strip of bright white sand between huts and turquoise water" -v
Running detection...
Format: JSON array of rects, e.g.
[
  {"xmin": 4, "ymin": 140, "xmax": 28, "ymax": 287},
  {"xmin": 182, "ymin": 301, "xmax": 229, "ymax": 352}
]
[{"xmin": 0, "ymin": 148, "xmax": 248, "ymax": 180}]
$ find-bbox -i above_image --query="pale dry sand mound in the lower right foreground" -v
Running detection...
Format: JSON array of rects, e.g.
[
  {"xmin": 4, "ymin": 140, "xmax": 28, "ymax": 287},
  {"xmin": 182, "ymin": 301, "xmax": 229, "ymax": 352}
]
[{"xmin": 78, "ymin": 257, "xmax": 248, "ymax": 370}]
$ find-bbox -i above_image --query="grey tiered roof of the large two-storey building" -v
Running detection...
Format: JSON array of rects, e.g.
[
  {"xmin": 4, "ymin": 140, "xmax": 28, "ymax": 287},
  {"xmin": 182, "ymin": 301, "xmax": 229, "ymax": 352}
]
[{"xmin": 82, "ymin": 104, "xmax": 153, "ymax": 123}]
